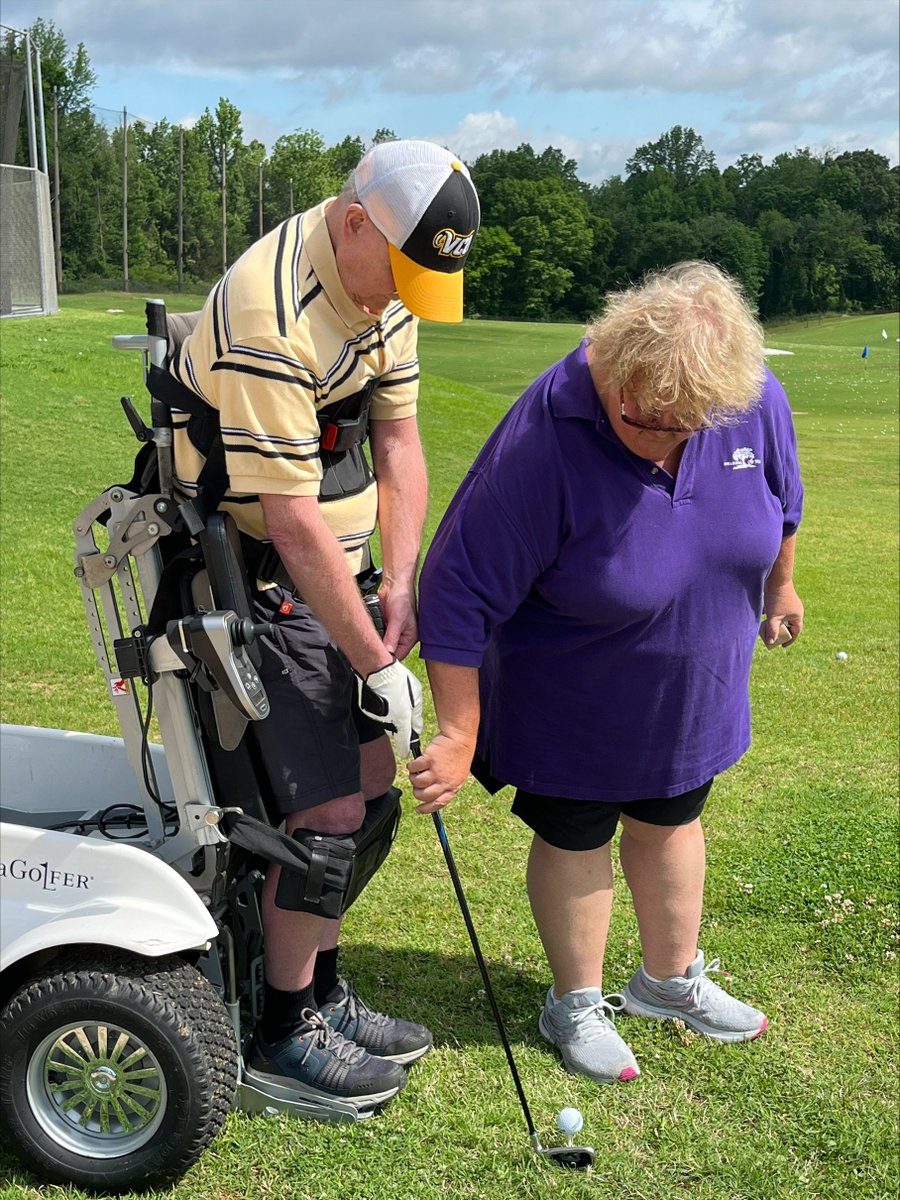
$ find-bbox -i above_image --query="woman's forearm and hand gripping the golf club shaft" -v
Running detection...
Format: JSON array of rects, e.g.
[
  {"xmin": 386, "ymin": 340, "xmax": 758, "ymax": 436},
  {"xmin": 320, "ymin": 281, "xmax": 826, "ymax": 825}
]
[{"xmin": 409, "ymin": 660, "xmax": 480, "ymax": 812}]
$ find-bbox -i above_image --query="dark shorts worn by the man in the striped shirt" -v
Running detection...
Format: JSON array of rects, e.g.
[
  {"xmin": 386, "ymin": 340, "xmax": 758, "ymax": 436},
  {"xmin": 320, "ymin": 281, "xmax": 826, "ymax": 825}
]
[{"xmin": 253, "ymin": 588, "xmax": 384, "ymax": 814}]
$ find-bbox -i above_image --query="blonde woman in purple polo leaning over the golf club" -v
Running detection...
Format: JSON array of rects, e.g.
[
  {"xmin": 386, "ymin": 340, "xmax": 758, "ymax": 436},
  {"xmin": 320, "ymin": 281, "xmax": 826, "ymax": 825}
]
[{"xmin": 409, "ymin": 263, "xmax": 803, "ymax": 1082}]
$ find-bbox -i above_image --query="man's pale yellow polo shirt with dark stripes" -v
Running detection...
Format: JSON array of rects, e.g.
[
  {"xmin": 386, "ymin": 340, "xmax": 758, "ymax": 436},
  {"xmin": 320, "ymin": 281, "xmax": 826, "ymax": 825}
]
[{"xmin": 170, "ymin": 200, "xmax": 419, "ymax": 572}]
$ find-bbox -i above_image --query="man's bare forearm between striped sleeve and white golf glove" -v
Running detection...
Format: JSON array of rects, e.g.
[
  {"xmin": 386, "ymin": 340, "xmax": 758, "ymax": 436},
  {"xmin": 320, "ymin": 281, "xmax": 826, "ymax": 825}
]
[{"xmin": 259, "ymin": 494, "xmax": 392, "ymax": 679}]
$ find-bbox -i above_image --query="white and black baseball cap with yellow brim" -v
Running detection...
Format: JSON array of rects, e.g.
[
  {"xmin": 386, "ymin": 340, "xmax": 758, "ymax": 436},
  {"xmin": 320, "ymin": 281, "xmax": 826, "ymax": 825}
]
[{"xmin": 353, "ymin": 140, "xmax": 481, "ymax": 322}]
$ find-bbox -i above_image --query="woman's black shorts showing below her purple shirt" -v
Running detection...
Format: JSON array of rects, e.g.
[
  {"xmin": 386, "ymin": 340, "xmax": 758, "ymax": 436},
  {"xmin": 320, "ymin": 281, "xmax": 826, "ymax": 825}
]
[{"xmin": 512, "ymin": 779, "xmax": 713, "ymax": 850}]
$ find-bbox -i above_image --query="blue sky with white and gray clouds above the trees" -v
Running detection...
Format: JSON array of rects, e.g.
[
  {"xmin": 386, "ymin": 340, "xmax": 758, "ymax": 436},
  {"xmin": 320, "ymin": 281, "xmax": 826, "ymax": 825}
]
[{"xmin": 0, "ymin": 0, "xmax": 900, "ymax": 182}]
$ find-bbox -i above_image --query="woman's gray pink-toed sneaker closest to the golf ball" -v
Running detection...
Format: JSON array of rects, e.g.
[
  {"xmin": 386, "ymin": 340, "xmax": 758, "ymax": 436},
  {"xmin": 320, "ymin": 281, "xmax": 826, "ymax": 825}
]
[{"xmin": 538, "ymin": 988, "xmax": 641, "ymax": 1084}]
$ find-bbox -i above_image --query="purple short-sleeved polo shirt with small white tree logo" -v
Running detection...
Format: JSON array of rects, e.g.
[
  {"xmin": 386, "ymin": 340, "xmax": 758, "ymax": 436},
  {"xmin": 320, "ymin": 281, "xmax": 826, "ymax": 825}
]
[{"xmin": 420, "ymin": 346, "xmax": 803, "ymax": 803}]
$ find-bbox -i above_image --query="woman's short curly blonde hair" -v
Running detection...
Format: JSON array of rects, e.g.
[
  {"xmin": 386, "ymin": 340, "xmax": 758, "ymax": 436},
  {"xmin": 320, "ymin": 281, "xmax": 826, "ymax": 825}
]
[{"xmin": 587, "ymin": 262, "xmax": 764, "ymax": 428}]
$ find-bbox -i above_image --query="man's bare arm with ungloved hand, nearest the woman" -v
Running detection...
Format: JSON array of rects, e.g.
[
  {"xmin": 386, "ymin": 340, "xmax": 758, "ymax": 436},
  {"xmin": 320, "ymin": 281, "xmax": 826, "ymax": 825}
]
[{"xmin": 370, "ymin": 416, "xmax": 428, "ymax": 659}]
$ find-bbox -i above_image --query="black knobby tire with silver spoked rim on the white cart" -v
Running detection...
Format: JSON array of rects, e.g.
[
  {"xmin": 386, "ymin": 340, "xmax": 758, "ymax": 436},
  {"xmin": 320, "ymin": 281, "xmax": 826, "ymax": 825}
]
[{"xmin": 0, "ymin": 950, "xmax": 238, "ymax": 1192}]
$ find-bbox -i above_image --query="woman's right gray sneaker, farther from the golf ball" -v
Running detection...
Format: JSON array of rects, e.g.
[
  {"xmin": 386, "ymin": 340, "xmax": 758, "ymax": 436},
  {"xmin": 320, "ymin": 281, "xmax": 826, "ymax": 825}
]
[{"xmin": 624, "ymin": 950, "xmax": 769, "ymax": 1042}]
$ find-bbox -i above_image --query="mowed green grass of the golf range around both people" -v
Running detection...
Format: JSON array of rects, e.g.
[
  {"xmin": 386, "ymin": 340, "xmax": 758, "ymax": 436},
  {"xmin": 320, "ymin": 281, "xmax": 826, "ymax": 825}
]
[{"xmin": 0, "ymin": 295, "xmax": 900, "ymax": 1200}]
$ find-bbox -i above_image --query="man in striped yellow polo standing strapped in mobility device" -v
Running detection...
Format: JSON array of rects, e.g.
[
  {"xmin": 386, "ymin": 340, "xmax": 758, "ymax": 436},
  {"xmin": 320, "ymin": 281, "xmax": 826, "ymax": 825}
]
[{"xmin": 170, "ymin": 140, "xmax": 479, "ymax": 1108}]
